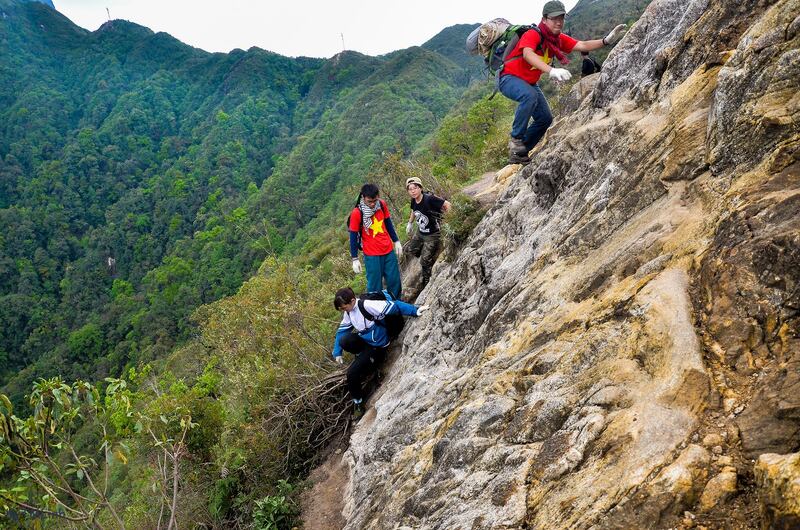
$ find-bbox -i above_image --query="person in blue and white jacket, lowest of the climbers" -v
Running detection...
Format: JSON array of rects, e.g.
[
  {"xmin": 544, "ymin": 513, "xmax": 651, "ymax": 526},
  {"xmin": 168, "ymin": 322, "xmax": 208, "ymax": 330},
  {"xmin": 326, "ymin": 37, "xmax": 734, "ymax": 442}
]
[{"xmin": 333, "ymin": 287, "xmax": 428, "ymax": 419}]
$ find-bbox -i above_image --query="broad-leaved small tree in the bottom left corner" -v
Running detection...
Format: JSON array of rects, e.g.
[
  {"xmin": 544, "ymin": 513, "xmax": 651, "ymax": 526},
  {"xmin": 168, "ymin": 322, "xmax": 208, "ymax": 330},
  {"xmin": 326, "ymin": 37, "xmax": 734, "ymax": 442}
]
[{"xmin": 0, "ymin": 377, "xmax": 131, "ymax": 528}]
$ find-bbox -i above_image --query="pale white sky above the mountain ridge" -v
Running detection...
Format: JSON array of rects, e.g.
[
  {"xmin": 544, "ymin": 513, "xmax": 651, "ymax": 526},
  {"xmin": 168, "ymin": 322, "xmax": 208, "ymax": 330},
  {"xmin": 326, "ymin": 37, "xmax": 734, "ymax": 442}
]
[{"xmin": 53, "ymin": 0, "xmax": 577, "ymax": 57}]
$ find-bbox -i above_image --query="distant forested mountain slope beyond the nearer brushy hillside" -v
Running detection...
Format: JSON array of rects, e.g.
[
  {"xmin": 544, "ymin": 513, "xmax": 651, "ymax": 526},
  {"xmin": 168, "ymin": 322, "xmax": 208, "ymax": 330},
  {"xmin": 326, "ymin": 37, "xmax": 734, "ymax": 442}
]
[{"xmin": 0, "ymin": 0, "xmax": 470, "ymax": 402}]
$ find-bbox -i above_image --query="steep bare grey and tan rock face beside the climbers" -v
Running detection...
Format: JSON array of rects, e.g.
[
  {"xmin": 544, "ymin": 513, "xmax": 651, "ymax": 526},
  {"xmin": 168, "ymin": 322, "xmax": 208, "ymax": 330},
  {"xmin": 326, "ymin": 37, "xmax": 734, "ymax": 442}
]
[{"xmin": 343, "ymin": 0, "xmax": 800, "ymax": 530}]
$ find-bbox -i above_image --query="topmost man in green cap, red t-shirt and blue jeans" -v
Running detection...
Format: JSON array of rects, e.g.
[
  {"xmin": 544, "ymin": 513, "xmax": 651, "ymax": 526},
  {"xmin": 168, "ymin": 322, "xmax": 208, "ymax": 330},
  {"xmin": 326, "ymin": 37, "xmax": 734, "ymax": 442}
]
[{"xmin": 498, "ymin": 0, "xmax": 625, "ymax": 164}]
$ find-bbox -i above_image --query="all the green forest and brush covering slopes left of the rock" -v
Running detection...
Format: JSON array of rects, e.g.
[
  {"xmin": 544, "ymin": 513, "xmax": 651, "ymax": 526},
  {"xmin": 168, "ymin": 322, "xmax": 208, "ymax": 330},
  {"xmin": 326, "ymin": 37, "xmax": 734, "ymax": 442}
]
[{"xmin": 0, "ymin": 0, "xmax": 643, "ymax": 528}]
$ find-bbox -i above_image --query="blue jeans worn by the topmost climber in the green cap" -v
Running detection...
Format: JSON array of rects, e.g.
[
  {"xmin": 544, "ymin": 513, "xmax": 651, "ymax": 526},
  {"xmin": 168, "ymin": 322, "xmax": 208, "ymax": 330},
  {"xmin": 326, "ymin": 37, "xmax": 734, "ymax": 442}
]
[{"xmin": 499, "ymin": 75, "xmax": 553, "ymax": 151}]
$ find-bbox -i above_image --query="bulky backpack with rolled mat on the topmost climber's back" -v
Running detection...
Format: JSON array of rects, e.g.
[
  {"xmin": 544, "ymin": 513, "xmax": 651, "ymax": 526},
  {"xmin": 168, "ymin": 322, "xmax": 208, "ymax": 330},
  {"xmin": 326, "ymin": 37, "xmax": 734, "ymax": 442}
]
[{"xmin": 467, "ymin": 18, "xmax": 544, "ymax": 76}]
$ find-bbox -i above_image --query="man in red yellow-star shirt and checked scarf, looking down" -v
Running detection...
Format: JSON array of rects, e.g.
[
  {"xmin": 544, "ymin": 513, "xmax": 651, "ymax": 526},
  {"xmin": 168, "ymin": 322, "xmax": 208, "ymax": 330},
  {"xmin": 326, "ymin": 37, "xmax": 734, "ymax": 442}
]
[{"xmin": 349, "ymin": 184, "xmax": 403, "ymax": 300}]
